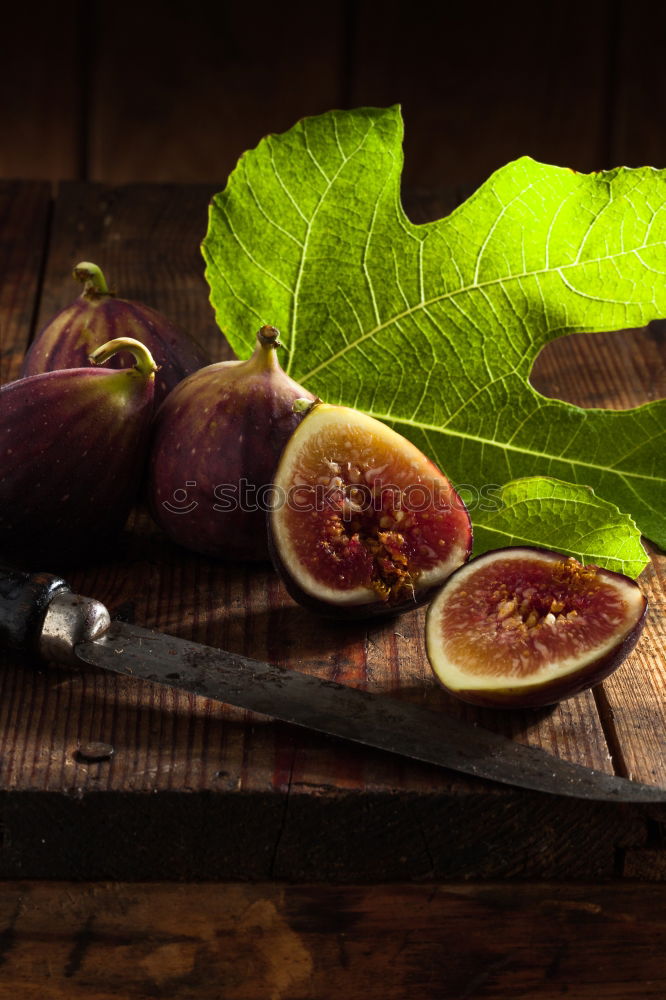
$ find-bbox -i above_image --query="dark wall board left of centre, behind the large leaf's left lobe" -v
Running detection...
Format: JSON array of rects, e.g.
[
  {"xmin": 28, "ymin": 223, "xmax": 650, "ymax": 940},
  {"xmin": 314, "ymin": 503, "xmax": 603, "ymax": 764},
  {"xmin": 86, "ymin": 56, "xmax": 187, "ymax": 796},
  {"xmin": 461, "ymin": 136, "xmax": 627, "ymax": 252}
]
[{"xmin": 90, "ymin": 0, "xmax": 343, "ymax": 186}]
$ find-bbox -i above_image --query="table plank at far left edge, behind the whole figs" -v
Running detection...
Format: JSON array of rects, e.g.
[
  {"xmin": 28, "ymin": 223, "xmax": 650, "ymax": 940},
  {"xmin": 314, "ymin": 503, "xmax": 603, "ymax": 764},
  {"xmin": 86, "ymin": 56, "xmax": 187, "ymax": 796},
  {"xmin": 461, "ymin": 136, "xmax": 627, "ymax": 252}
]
[{"xmin": 0, "ymin": 181, "xmax": 51, "ymax": 384}]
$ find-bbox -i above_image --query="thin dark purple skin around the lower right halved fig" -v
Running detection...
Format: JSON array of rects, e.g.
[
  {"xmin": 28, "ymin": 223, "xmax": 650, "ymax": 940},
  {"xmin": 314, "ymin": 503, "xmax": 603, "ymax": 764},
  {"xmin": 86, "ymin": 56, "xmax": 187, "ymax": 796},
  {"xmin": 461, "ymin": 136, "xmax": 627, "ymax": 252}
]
[{"xmin": 426, "ymin": 545, "xmax": 648, "ymax": 709}]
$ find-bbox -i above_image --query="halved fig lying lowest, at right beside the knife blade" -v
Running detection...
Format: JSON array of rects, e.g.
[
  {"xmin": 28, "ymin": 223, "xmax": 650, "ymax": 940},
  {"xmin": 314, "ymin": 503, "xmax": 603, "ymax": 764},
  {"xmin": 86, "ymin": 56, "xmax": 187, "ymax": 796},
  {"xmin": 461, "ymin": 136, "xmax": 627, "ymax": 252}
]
[{"xmin": 426, "ymin": 548, "xmax": 647, "ymax": 708}]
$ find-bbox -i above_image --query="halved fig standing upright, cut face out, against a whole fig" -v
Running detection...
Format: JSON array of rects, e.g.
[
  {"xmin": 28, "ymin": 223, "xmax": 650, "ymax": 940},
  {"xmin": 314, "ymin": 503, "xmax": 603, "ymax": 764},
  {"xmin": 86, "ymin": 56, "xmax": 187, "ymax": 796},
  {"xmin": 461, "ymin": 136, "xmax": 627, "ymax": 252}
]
[{"xmin": 269, "ymin": 403, "xmax": 472, "ymax": 618}]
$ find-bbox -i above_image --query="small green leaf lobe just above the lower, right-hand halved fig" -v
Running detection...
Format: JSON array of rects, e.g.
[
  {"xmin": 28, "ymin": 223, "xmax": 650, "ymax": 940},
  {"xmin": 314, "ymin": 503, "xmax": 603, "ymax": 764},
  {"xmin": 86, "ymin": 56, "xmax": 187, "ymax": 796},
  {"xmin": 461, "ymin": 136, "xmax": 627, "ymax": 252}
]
[{"xmin": 472, "ymin": 476, "xmax": 650, "ymax": 578}]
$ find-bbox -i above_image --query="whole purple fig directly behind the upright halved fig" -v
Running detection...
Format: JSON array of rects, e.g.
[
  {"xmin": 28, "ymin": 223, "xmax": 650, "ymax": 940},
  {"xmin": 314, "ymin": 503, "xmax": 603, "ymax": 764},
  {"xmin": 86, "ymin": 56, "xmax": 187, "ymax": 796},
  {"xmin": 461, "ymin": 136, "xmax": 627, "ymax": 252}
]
[{"xmin": 149, "ymin": 326, "xmax": 314, "ymax": 560}]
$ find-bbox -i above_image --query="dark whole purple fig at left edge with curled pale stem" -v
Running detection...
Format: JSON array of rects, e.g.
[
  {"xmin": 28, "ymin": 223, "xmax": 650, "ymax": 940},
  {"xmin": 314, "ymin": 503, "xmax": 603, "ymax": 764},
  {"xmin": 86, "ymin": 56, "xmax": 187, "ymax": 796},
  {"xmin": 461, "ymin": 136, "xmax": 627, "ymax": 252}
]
[{"xmin": 0, "ymin": 337, "xmax": 156, "ymax": 570}]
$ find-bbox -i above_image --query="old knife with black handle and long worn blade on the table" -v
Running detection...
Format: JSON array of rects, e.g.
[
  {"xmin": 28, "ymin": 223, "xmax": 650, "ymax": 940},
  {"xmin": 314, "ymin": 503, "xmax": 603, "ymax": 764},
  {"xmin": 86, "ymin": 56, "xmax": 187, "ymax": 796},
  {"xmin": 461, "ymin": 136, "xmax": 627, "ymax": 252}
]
[{"xmin": 0, "ymin": 566, "xmax": 666, "ymax": 803}]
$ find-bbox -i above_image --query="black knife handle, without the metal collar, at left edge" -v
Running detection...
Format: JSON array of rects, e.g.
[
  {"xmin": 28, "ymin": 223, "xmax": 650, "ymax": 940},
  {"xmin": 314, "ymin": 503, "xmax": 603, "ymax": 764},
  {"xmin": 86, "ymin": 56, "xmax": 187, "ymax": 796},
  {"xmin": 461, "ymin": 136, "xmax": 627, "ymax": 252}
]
[{"xmin": 0, "ymin": 563, "xmax": 69, "ymax": 652}]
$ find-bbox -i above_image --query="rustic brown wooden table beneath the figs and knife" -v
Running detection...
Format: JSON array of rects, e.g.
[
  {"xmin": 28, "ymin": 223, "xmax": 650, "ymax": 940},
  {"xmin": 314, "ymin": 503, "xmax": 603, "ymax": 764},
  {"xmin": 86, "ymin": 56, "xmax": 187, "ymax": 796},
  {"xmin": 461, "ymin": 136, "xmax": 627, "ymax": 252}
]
[{"xmin": 0, "ymin": 182, "xmax": 666, "ymax": 1000}]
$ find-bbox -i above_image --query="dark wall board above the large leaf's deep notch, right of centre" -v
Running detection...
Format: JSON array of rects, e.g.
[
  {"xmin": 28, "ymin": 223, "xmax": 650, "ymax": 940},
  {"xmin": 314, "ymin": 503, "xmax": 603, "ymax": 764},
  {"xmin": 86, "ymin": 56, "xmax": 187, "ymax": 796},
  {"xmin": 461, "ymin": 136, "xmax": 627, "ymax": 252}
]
[{"xmin": 350, "ymin": 0, "xmax": 608, "ymax": 188}]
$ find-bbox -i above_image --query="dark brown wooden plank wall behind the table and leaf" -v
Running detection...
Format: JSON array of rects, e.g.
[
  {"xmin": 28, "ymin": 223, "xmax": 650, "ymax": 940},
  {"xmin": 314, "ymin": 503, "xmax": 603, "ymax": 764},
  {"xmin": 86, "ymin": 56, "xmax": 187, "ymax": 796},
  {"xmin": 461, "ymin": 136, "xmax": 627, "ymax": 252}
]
[{"xmin": 0, "ymin": 0, "xmax": 666, "ymax": 189}]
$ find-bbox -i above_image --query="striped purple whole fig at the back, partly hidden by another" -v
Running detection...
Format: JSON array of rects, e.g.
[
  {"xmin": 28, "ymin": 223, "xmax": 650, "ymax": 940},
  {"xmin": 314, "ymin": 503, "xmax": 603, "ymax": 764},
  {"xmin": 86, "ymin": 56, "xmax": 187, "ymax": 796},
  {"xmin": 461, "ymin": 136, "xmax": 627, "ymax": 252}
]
[{"xmin": 21, "ymin": 261, "xmax": 210, "ymax": 405}]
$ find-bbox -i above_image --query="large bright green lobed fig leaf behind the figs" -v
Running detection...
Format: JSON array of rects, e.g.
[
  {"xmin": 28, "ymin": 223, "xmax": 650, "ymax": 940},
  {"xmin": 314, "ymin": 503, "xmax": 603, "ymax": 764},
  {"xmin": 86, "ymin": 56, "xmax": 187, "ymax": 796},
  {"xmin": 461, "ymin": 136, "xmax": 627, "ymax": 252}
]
[{"xmin": 203, "ymin": 108, "xmax": 666, "ymax": 558}]
